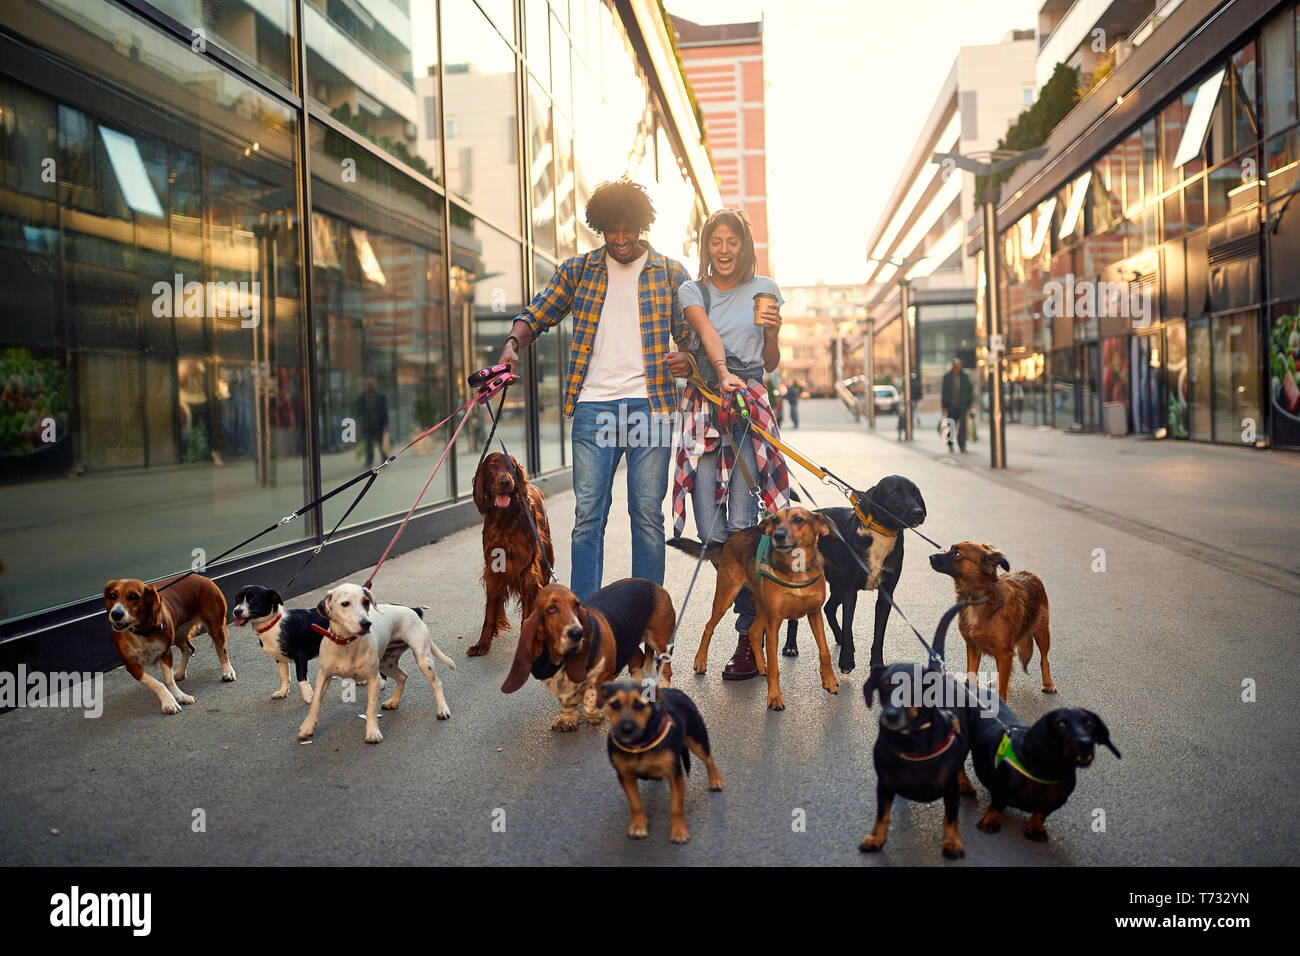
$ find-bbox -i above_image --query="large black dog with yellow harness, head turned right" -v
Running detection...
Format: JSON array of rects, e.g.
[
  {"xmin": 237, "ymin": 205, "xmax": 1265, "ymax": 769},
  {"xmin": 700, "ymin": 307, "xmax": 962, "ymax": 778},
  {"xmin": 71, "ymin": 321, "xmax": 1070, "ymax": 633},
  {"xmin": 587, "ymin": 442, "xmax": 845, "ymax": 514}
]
[{"xmin": 781, "ymin": 475, "xmax": 926, "ymax": 674}]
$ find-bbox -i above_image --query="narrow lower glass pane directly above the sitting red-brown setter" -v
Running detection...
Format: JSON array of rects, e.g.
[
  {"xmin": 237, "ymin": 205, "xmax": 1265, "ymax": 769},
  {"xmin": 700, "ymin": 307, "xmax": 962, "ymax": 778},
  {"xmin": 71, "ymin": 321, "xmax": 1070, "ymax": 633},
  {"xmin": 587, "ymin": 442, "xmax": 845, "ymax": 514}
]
[{"xmin": 450, "ymin": 213, "xmax": 528, "ymax": 497}]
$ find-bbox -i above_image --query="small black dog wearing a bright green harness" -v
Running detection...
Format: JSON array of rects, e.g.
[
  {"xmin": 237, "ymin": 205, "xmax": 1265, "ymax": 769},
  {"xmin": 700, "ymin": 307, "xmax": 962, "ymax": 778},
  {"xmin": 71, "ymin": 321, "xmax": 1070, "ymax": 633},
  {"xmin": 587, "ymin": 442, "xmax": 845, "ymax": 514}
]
[{"xmin": 970, "ymin": 704, "xmax": 1119, "ymax": 842}]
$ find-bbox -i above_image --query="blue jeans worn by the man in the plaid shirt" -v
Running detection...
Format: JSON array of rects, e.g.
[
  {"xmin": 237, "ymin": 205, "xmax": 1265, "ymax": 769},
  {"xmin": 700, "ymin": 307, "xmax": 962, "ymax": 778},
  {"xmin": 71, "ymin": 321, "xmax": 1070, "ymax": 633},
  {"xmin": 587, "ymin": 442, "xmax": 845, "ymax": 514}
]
[{"xmin": 569, "ymin": 398, "xmax": 672, "ymax": 601}]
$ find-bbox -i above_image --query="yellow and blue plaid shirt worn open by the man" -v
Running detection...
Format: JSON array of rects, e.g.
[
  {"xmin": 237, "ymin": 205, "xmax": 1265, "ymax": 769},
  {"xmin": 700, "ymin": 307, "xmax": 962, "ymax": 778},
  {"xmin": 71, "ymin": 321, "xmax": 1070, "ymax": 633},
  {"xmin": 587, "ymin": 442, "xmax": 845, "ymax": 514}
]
[{"xmin": 517, "ymin": 243, "xmax": 690, "ymax": 418}]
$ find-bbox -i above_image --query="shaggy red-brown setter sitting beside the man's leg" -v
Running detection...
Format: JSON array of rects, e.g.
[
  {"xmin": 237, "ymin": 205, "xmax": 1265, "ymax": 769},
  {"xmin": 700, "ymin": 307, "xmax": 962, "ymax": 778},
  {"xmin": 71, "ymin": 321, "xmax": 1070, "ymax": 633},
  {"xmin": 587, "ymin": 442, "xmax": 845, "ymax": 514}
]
[{"xmin": 465, "ymin": 451, "xmax": 555, "ymax": 657}]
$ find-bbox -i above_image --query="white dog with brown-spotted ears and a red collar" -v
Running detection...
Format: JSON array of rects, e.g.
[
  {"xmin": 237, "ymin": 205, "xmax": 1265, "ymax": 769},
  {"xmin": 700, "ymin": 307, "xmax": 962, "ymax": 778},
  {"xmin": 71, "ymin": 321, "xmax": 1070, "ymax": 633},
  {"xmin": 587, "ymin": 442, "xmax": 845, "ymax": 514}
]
[{"xmin": 298, "ymin": 584, "xmax": 456, "ymax": 744}]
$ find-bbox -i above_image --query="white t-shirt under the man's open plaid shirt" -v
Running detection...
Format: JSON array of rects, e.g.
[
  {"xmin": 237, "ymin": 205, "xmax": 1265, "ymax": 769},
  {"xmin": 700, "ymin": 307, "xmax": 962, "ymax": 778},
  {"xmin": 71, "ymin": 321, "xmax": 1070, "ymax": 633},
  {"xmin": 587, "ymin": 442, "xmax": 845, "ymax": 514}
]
[{"xmin": 577, "ymin": 248, "xmax": 650, "ymax": 402}]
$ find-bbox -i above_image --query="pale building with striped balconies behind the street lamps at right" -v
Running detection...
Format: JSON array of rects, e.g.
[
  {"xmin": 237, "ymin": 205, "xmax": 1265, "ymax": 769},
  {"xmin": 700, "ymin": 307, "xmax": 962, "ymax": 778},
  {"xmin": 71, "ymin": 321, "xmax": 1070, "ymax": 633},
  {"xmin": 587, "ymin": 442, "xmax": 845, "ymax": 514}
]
[{"xmin": 850, "ymin": 30, "xmax": 1037, "ymax": 398}]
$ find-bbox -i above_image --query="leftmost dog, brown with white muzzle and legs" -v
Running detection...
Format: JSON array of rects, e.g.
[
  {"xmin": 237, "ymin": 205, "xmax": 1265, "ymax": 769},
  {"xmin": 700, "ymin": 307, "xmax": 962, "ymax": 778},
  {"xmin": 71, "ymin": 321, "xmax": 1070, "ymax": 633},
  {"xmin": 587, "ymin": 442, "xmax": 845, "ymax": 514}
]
[{"xmin": 104, "ymin": 575, "xmax": 235, "ymax": 714}]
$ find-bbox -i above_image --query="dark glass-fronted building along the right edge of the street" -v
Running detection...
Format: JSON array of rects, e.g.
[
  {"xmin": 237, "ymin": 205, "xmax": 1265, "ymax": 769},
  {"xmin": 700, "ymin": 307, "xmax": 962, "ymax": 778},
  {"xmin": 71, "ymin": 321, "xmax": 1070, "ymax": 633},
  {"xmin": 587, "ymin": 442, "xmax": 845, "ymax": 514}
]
[{"xmin": 967, "ymin": 0, "xmax": 1300, "ymax": 447}]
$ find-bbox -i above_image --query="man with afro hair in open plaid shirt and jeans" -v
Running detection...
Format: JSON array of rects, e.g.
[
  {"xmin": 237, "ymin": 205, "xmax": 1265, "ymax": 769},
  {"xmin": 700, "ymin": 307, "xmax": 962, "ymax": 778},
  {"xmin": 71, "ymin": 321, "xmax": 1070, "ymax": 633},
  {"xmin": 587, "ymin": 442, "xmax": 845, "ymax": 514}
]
[{"xmin": 501, "ymin": 178, "xmax": 690, "ymax": 601}]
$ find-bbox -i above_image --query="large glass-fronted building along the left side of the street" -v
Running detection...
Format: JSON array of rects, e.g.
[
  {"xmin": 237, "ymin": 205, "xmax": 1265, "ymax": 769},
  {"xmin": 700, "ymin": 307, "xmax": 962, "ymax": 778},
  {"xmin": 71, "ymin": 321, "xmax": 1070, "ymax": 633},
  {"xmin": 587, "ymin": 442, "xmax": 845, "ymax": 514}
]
[{"xmin": 0, "ymin": 0, "xmax": 720, "ymax": 669}]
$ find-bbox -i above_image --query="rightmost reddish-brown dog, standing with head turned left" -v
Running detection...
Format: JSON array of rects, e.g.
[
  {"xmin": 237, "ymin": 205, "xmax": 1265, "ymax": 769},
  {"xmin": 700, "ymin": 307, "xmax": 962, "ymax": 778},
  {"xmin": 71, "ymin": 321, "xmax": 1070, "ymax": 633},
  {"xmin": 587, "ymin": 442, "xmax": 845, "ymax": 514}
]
[{"xmin": 930, "ymin": 541, "xmax": 1056, "ymax": 700}]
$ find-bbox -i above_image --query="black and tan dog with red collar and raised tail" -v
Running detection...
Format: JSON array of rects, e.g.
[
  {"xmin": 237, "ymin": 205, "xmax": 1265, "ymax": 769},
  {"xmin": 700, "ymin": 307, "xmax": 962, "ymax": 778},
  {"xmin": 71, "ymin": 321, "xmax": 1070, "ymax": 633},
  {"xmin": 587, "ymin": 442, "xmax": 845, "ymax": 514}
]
[{"xmin": 858, "ymin": 605, "xmax": 978, "ymax": 860}]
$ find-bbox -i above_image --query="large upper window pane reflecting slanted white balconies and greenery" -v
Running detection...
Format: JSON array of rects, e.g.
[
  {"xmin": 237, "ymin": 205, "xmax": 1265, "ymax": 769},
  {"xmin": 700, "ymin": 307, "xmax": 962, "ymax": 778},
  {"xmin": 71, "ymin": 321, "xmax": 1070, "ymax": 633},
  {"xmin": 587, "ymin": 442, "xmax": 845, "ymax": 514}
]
[{"xmin": 303, "ymin": 0, "xmax": 441, "ymax": 182}]
